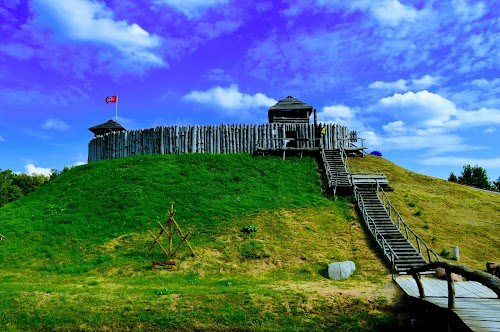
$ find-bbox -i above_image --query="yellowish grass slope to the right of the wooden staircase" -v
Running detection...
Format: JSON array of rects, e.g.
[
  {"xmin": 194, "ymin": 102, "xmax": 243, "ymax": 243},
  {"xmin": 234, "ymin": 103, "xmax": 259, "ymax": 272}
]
[{"xmin": 349, "ymin": 156, "xmax": 500, "ymax": 270}]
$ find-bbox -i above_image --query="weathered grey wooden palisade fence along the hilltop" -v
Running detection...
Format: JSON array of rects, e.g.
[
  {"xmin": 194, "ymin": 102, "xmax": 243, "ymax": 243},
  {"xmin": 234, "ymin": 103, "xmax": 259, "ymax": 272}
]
[{"xmin": 88, "ymin": 123, "xmax": 356, "ymax": 162}]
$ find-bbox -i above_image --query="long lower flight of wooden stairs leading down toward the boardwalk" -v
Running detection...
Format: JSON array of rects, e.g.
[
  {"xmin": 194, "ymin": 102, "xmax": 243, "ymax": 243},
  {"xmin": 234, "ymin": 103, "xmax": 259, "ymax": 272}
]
[{"xmin": 355, "ymin": 187, "xmax": 427, "ymax": 274}]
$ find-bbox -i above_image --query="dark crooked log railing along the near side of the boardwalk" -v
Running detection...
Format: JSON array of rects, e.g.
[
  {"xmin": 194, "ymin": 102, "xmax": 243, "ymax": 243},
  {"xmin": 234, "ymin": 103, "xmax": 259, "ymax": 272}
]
[{"xmin": 410, "ymin": 262, "xmax": 500, "ymax": 309}]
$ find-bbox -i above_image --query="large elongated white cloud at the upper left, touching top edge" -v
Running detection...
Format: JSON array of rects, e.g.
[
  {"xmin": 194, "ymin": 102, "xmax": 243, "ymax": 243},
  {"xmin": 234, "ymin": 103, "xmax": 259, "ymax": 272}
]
[{"xmin": 32, "ymin": 0, "xmax": 166, "ymax": 67}]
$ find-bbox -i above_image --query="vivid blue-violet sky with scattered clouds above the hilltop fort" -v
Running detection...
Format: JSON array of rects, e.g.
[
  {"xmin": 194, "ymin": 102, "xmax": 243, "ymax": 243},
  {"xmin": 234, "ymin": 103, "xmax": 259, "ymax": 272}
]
[{"xmin": 0, "ymin": 0, "xmax": 500, "ymax": 180}]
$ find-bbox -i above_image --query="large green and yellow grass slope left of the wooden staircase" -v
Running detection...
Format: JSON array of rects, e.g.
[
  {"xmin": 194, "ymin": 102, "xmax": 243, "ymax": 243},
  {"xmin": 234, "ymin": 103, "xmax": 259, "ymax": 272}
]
[{"xmin": 0, "ymin": 154, "xmax": 400, "ymax": 331}]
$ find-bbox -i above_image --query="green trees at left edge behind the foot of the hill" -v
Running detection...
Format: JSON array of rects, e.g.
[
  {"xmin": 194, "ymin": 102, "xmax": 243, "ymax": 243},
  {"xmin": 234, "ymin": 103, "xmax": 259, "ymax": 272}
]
[{"xmin": 0, "ymin": 167, "xmax": 69, "ymax": 207}]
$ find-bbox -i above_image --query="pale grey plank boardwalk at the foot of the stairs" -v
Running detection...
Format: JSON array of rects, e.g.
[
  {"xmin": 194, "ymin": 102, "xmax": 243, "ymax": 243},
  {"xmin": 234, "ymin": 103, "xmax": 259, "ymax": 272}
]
[{"xmin": 394, "ymin": 277, "xmax": 500, "ymax": 332}]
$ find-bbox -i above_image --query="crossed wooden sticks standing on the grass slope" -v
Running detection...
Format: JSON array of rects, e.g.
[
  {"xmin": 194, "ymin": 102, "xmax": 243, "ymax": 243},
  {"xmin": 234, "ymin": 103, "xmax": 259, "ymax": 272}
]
[{"xmin": 147, "ymin": 202, "xmax": 196, "ymax": 268}]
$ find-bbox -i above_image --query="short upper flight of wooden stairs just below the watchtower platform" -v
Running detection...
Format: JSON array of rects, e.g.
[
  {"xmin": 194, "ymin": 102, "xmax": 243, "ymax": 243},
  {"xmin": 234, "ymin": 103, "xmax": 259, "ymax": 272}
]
[{"xmin": 321, "ymin": 149, "xmax": 352, "ymax": 196}]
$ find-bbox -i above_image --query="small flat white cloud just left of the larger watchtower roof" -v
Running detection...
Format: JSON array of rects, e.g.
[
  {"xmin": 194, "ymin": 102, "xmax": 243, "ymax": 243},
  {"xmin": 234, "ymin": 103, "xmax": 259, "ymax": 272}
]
[{"xmin": 184, "ymin": 84, "xmax": 277, "ymax": 111}]
